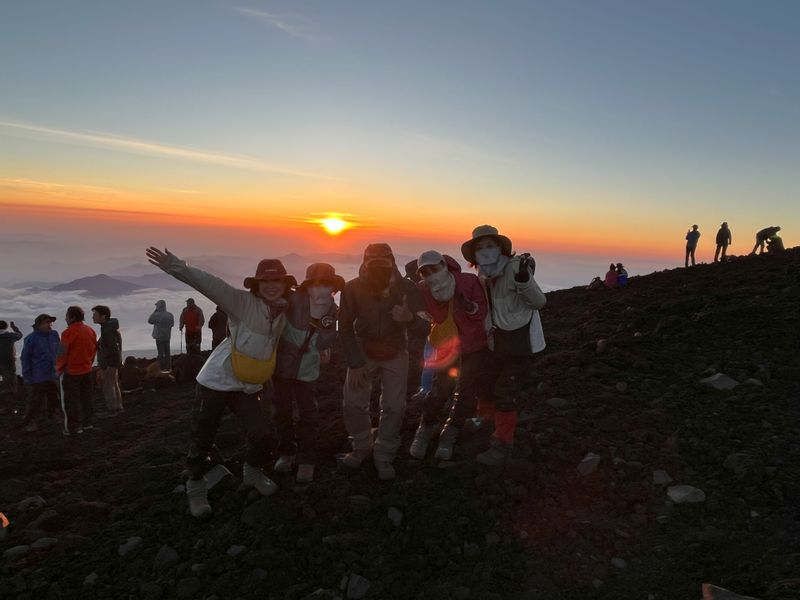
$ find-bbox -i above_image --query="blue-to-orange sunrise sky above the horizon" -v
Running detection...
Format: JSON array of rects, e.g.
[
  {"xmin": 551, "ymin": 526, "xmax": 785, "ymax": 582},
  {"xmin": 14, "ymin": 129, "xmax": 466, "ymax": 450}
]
[{"xmin": 0, "ymin": 0, "xmax": 800, "ymax": 284}]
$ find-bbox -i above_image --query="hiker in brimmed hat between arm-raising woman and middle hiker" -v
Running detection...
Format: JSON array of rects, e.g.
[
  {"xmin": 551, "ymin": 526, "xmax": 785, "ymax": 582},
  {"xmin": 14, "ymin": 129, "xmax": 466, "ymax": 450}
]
[{"xmin": 272, "ymin": 263, "xmax": 345, "ymax": 483}]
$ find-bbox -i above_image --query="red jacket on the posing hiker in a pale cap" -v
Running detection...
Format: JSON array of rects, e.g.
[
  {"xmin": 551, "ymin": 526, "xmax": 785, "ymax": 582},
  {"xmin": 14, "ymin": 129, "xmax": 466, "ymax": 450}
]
[{"xmin": 417, "ymin": 255, "xmax": 489, "ymax": 354}]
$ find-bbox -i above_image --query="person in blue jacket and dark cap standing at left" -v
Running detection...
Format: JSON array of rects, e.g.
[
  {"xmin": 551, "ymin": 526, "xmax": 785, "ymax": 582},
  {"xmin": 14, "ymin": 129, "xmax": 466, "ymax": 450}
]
[{"xmin": 20, "ymin": 314, "xmax": 59, "ymax": 432}]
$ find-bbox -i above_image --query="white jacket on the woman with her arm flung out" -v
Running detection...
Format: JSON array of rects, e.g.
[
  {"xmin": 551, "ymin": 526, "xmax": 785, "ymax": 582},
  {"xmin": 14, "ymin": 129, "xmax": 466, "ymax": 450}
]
[{"xmin": 164, "ymin": 255, "xmax": 286, "ymax": 394}]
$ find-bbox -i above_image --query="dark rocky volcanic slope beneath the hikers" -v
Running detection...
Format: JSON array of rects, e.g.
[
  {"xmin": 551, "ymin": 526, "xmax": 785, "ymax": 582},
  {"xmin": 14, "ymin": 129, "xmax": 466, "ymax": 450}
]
[{"xmin": 0, "ymin": 249, "xmax": 800, "ymax": 600}]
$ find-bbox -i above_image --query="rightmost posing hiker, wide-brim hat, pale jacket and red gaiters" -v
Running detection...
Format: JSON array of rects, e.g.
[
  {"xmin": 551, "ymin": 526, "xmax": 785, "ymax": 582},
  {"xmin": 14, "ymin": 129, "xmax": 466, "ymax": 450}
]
[{"xmin": 461, "ymin": 225, "xmax": 547, "ymax": 466}]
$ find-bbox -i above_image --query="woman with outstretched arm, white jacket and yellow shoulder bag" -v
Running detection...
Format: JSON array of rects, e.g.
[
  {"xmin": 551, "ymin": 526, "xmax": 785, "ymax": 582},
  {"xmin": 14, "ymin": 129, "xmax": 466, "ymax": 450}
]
[{"xmin": 146, "ymin": 246, "xmax": 297, "ymax": 517}]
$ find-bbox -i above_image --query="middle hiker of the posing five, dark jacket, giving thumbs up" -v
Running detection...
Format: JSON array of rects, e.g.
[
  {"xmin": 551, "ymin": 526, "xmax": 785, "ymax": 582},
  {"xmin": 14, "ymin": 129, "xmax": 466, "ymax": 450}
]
[{"xmin": 339, "ymin": 243, "xmax": 428, "ymax": 480}]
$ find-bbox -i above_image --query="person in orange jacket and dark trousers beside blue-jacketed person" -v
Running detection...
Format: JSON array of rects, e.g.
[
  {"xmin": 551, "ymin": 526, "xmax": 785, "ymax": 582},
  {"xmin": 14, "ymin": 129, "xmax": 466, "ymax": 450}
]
[{"xmin": 56, "ymin": 306, "xmax": 97, "ymax": 436}]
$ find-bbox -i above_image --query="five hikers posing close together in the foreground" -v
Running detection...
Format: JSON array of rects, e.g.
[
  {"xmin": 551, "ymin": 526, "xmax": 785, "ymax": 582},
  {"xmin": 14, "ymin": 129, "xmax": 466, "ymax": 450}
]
[{"xmin": 139, "ymin": 225, "xmax": 546, "ymax": 517}]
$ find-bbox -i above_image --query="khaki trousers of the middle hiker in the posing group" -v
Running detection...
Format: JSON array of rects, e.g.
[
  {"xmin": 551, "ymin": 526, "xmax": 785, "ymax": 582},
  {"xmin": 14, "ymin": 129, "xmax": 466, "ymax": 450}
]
[{"xmin": 342, "ymin": 350, "xmax": 408, "ymax": 461}]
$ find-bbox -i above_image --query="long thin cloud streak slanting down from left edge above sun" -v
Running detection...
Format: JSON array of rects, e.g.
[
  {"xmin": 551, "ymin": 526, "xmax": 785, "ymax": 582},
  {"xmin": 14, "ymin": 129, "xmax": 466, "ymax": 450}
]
[{"xmin": 0, "ymin": 121, "xmax": 329, "ymax": 179}]
